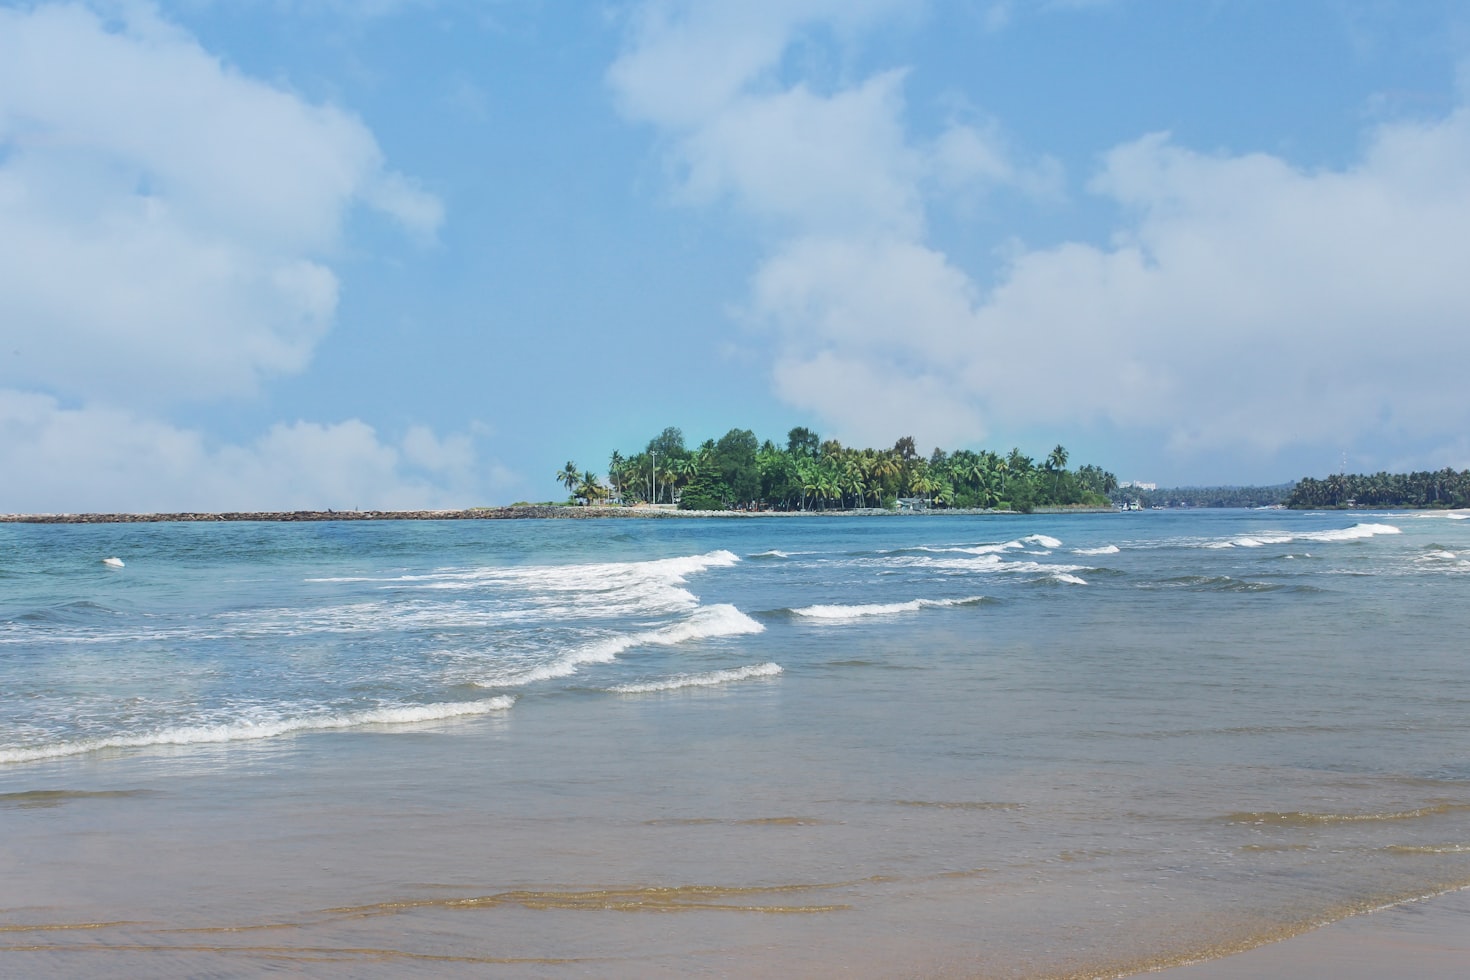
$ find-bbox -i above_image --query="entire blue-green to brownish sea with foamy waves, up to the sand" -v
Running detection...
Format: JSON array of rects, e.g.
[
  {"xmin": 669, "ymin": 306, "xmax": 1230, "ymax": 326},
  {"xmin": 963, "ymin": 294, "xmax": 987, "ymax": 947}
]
[{"xmin": 0, "ymin": 511, "xmax": 1470, "ymax": 977}]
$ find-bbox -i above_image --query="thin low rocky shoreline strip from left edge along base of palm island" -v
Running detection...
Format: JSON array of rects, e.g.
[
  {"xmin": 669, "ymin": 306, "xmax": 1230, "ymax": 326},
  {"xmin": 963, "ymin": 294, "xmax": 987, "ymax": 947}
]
[{"xmin": 0, "ymin": 505, "xmax": 1116, "ymax": 525}]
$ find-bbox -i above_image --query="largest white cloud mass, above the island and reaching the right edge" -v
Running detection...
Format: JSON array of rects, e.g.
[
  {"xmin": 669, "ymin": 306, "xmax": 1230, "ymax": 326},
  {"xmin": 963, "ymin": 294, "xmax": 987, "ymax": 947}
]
[{"xmin": 610, "ymin": 3, "xmax": 1470, "ymax": 470}]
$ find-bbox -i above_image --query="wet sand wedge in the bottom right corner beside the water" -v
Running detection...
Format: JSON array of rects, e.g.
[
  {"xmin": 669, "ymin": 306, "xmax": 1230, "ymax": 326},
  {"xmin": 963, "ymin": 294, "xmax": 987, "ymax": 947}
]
[{"xmin": 1160, "ymin": 889, "xmax": 1470, "ymax": 980}]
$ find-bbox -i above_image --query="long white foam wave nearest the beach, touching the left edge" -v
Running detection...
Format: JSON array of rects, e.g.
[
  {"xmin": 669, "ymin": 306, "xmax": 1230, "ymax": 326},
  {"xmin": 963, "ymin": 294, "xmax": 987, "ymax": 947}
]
[{"xmin": 0, "ymin": 695, "xmax": 516, "ymax": 763}]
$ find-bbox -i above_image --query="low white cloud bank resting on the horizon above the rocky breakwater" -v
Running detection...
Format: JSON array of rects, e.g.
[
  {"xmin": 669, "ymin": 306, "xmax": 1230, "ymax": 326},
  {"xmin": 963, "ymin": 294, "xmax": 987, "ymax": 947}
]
[{"xmin": 0, "ymin": 389, "xmax": 516, "ymax": 513}]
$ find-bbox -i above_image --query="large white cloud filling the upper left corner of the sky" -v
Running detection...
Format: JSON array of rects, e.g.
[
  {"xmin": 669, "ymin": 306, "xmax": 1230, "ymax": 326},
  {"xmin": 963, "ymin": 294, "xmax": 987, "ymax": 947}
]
[{"xmin": 0, "ymin": 4, "xmax": 442, "ymax": 406}]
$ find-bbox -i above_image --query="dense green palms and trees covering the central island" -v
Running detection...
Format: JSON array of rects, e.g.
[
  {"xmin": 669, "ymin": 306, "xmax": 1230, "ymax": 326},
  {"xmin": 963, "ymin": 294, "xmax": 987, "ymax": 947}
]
[{"xmin": 556, "ymin": 428, "xmax": 1117, "ymax": 511}]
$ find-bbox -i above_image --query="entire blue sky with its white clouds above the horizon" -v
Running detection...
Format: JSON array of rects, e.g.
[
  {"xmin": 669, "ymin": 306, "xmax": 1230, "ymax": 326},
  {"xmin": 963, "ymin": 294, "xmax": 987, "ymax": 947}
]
[{"xmin": 0, "ymin": 0, "xmax": 1470, "ymax": 513}]
